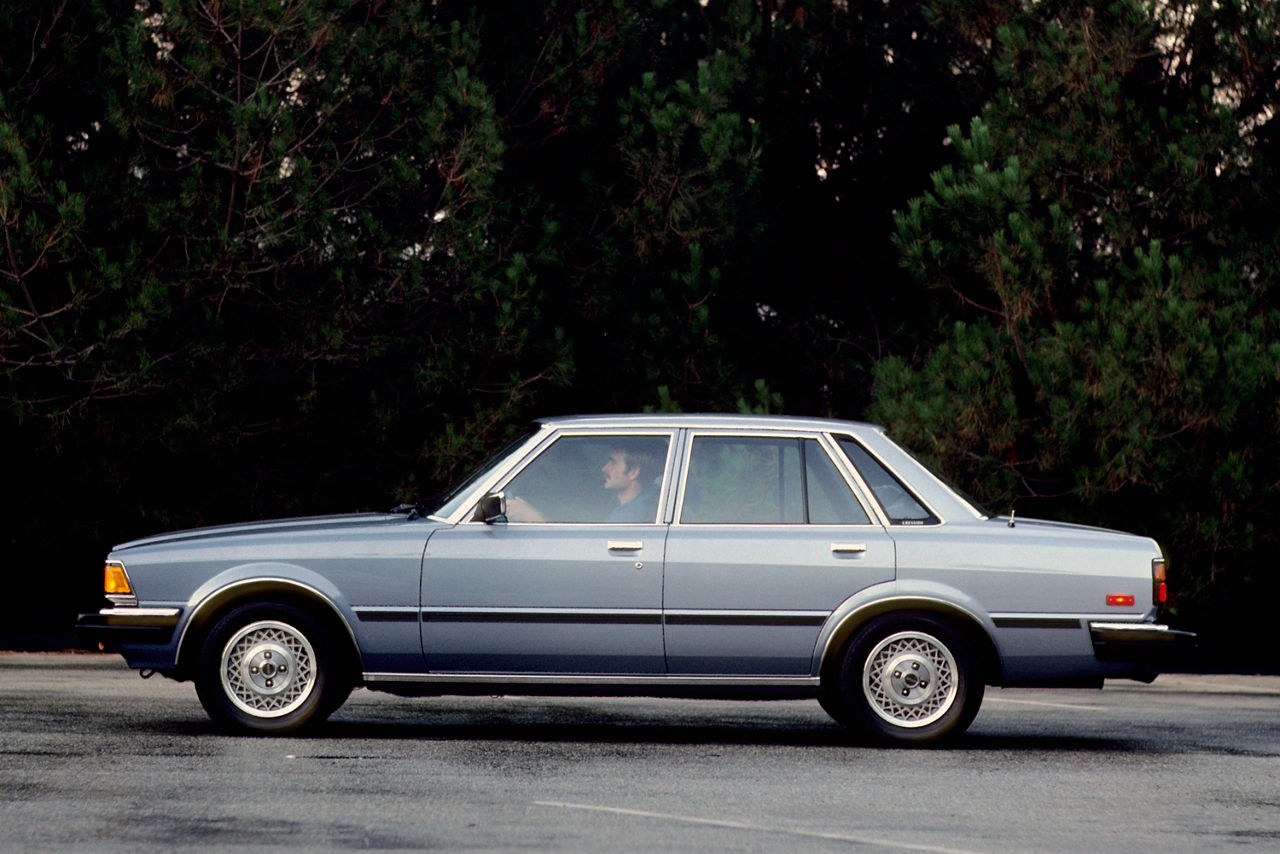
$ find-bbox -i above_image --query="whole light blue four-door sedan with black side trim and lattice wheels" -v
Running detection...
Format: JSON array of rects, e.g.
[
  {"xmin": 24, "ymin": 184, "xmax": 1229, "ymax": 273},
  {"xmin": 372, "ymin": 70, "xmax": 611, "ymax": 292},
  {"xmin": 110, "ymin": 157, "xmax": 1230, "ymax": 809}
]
[{"xmin": 78, "ymin": 415, "xmax": 1194, "ymax": 744}]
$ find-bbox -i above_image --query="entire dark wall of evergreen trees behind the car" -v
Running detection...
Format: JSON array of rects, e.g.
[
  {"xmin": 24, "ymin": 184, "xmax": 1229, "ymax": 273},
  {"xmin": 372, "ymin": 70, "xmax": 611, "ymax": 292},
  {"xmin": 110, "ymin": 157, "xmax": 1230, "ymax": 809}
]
[{"xmin": 0, "ymin": 0, "xmax": 1280, "ymax": 666}]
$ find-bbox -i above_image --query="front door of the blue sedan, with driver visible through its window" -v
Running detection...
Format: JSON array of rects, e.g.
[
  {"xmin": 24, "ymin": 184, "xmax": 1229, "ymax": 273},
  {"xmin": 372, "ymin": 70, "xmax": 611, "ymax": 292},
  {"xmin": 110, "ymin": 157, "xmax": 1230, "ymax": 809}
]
[{"xmin": 421, "ymin": 430, "xmax": 673, "ymax": 675}]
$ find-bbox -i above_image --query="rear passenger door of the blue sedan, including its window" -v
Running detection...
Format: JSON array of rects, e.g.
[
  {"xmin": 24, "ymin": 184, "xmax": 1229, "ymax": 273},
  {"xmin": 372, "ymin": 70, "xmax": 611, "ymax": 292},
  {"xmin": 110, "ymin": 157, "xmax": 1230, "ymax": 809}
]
[{"xmin": 663, "ymin": 431, "xmax": 893, "ymax": 675}]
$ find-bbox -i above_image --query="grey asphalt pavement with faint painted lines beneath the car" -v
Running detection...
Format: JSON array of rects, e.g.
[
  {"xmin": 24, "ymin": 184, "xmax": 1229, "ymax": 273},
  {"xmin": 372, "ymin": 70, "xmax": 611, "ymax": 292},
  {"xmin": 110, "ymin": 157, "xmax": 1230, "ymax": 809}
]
[{"xmin": 0, "ymin": 654, "xmax": 1280, "ymax": 854}]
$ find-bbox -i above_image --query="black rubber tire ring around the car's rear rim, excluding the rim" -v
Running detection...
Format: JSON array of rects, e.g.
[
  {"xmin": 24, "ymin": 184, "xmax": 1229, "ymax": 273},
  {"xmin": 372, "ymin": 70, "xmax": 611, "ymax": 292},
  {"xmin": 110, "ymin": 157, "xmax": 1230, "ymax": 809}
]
[{"xmin": 838, "ymin": 615, "xmax": 983, "ymax": 745}]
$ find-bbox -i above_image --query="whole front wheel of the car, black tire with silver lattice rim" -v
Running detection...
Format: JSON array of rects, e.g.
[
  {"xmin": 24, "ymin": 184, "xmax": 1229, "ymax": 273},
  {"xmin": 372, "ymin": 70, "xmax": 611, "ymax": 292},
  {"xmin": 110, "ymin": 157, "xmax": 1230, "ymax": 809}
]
[{"xmin": 195, "ymin": 603, "xmax": 352, "ymax": 735}]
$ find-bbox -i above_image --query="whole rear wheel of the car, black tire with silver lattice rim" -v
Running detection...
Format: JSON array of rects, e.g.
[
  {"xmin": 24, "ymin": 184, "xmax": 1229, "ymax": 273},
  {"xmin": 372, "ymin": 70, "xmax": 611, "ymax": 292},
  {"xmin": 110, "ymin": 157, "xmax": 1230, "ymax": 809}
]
[{"xmin": 824, "ymin": 615, "xmax": 984, "ymax": 745}]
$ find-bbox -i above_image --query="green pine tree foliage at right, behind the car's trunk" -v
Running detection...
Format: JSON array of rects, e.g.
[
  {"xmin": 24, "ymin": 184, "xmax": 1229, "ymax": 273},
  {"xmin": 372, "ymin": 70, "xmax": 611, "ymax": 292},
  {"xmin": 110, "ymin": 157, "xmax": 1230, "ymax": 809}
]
[{"xmin": 872, "ymin": 3, "xmax": 1280, "ymax": 640}]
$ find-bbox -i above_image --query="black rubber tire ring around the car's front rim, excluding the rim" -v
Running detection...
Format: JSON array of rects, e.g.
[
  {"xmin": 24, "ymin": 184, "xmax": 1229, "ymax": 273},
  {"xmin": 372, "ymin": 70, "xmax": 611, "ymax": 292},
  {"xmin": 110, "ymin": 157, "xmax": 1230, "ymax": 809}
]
[{"xmin": 195, "ymin": 603, "xmax": 342, "ymax": 735}]
